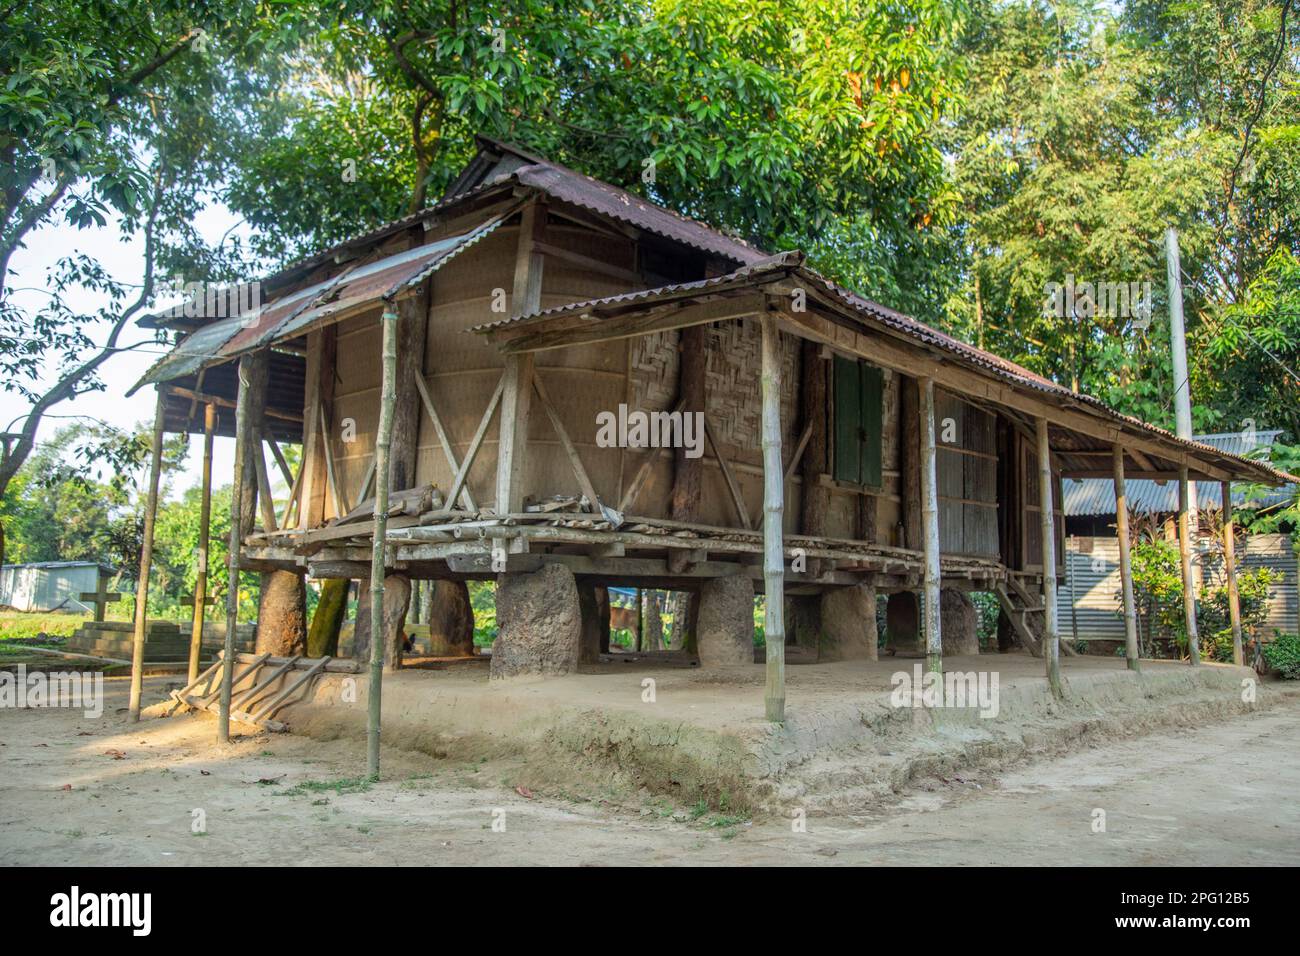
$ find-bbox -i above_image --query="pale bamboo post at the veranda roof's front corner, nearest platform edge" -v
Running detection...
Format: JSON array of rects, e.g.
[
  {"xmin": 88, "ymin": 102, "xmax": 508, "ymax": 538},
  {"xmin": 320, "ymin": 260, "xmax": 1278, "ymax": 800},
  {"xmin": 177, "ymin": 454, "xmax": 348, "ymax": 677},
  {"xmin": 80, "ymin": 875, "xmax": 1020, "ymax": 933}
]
[{"xmin": 761, "ymin": 315, "xmax": 785, "ymax": 723}]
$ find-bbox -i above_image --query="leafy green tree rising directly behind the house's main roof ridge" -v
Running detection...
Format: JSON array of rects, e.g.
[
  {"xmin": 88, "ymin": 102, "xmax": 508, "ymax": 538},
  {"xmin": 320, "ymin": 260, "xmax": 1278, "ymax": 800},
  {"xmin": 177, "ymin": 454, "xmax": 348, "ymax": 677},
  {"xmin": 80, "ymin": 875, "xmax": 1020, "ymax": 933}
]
[{"xmin": 226, "ymin": 0, "xmax": 957, "ymax": 312}]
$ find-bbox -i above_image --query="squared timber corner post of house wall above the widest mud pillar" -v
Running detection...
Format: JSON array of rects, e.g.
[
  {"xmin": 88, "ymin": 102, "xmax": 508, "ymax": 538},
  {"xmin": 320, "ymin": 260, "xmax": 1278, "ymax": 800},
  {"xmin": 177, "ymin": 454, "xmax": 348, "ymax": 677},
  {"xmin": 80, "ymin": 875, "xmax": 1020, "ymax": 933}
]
[{"xmin": 497, "ymin": 200, "xmax": 543, "ymax": 515}]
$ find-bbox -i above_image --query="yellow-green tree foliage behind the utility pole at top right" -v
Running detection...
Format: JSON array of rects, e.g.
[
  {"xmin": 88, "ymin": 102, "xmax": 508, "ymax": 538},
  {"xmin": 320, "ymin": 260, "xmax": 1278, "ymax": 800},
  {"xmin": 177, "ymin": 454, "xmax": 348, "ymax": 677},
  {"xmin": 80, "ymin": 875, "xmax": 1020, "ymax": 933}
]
[{"xmin": 949, "ymin": 0, "xmax": 1300, "ymax": 429}]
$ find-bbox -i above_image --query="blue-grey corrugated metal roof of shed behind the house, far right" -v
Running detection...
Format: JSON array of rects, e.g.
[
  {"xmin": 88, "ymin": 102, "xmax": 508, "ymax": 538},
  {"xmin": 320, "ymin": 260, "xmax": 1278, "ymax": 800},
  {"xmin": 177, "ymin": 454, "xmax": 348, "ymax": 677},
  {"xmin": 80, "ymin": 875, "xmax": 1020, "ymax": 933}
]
[{"xmin": 1061, "ymin": 431, "xmax": 1295, "ymax": 518}]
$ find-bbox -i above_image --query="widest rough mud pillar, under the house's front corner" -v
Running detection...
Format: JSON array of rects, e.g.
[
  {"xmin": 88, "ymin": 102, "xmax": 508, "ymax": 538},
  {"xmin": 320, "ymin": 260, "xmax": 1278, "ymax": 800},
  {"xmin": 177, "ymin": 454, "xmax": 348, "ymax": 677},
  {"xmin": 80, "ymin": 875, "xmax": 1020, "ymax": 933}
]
[{"xmin": 490, "ymin": 564, "xmax": 582, "ymax": 680}]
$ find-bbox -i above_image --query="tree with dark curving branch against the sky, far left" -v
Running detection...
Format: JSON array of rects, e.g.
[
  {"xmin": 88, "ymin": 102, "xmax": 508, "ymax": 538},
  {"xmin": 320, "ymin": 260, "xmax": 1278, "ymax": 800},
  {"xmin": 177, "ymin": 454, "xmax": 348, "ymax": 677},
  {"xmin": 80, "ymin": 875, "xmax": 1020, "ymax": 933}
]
[{"xmin": 0, "ymin": 0, "xmax": 283, "ymax": 558}]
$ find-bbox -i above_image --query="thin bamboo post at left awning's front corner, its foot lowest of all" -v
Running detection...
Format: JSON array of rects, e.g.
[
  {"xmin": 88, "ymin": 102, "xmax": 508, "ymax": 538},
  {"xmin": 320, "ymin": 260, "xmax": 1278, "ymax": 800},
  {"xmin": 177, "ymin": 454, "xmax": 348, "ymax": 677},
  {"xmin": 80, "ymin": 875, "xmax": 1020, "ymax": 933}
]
[{"xmin": 365, "ymin": 303, "xmax": 398, "ymax": 779}]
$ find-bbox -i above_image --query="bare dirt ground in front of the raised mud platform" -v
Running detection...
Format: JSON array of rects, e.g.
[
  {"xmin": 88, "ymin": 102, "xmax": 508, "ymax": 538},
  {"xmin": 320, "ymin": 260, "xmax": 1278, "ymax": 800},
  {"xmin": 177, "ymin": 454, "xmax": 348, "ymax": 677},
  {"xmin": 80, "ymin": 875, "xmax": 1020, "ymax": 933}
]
[{"xmin": 0, "ymin": 679, "xmax": 1300, "ymax": 865}]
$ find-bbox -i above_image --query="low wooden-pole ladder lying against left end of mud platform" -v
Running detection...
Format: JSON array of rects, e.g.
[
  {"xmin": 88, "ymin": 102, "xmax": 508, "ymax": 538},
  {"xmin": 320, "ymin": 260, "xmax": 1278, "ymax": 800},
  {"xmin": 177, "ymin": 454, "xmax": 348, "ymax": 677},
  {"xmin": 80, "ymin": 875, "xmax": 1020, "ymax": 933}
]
[{"xmin": 168, "ymin": 652, "xmax": 333, "ymax": 734}]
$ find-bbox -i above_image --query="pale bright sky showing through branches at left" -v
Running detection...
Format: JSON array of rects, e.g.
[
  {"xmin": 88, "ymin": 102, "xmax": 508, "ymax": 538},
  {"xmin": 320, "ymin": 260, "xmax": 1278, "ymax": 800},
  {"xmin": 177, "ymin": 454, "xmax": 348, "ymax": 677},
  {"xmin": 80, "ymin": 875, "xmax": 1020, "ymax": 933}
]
[{"xmin": 0, "ymin": 204, "xmax": 248, "ymax": 497}]
